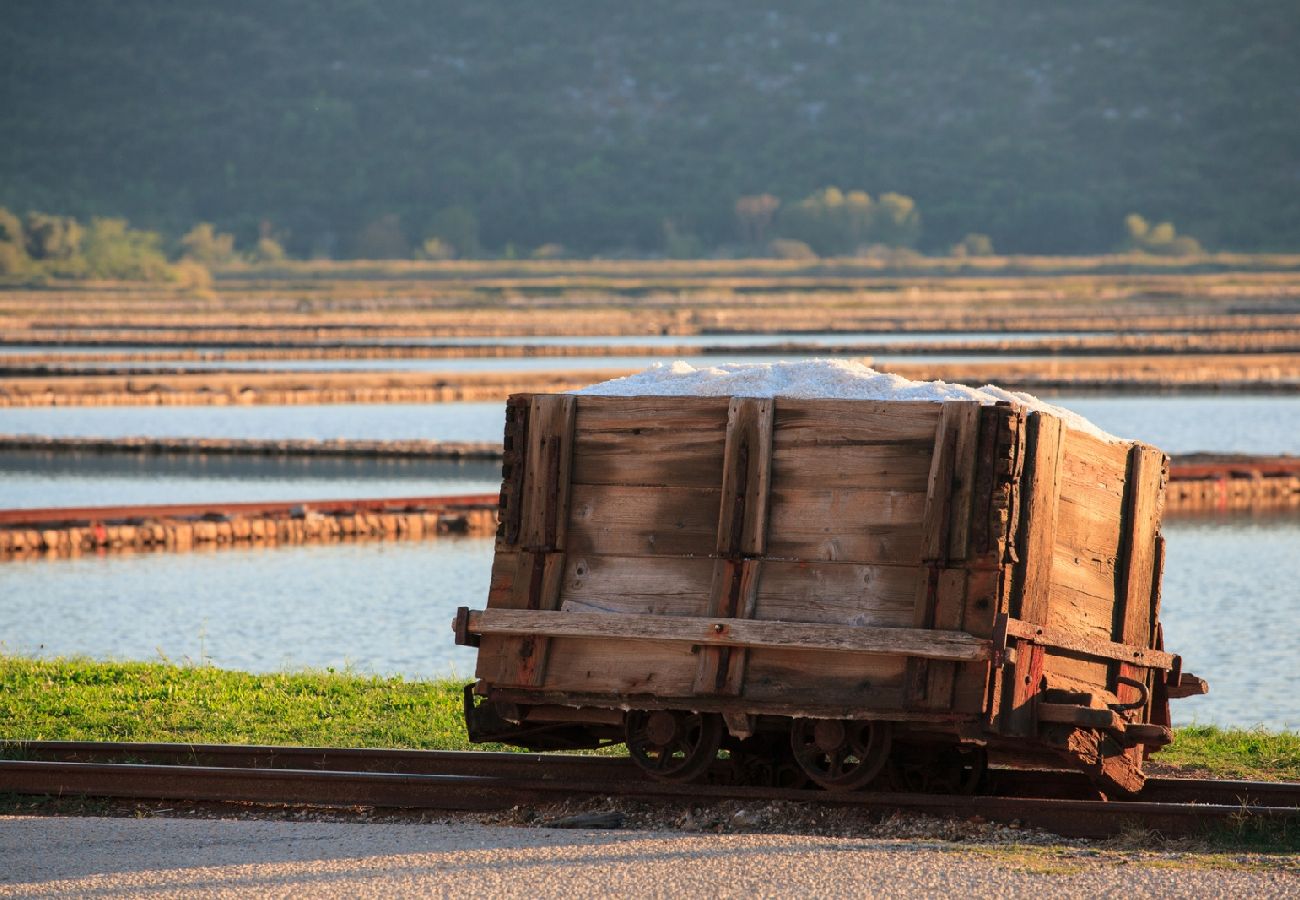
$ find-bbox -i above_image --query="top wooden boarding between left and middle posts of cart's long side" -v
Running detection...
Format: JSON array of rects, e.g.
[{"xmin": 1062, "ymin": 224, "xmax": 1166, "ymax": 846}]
[{"xmin": 572, "ymin": 397, "xmax": 728, "ymax": 489}]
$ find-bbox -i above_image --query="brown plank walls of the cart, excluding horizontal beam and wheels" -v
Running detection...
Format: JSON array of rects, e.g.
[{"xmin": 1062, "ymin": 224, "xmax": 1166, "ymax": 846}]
[{"xmin": 477, "ymin": 394, "xmax": 1162, "ymax": 728}]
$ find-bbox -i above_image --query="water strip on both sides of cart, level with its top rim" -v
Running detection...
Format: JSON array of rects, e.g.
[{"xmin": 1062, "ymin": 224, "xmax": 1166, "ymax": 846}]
[{"xmin": 0, "ymin": 395, "xmax": 1300, "ymax": 454}]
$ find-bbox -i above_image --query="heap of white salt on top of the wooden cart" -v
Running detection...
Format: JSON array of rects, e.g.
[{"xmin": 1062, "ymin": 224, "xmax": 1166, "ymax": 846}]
[{"xmin": 573, "ymin": 359, "xmax": 1122, "ymax": 442}]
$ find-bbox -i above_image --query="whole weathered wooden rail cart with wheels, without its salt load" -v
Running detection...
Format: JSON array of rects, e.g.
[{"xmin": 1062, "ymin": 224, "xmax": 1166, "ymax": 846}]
[{"xmin": 455, "ymin": 394, "xmax": 1205, "ymax": 792}]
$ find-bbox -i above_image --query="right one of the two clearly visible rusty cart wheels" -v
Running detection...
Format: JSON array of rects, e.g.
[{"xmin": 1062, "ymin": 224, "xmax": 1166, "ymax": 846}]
[{"xmin": 790, "ymin": 719, "xmax": 892, "ymax": 791}]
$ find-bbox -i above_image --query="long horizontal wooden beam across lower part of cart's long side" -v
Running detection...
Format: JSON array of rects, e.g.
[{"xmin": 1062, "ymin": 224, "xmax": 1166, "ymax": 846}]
[{"xmin": 468, "ymin": 610, "xmax": 991, "ymax": 661}]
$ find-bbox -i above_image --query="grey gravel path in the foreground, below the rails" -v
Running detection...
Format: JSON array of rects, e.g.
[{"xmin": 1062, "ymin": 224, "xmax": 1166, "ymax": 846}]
[{"xmin": 0, "ymin": 817, "xmax": 1300, "ymax": 899}]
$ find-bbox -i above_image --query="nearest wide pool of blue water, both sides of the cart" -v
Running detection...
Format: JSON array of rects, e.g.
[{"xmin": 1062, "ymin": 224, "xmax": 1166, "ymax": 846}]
[{"xmin": 0, "ymin": 519, "xmax": 1300, "ymax": 728}]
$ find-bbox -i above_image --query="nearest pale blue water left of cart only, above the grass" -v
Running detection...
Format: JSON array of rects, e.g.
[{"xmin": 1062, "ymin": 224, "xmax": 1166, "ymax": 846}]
[{"xmin": 0, "ymin": 537, "xmax": 493, "ymax": 675}]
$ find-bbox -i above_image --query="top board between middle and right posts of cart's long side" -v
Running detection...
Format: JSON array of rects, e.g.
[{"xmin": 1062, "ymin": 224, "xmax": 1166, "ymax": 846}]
[{"xmin": 776, "ymin": 399, "xmax": 940, "ymax": 450}]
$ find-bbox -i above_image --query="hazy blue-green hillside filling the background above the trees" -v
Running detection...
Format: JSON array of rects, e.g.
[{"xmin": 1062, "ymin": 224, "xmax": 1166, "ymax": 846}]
[{"xmin": 0, "ymin": 0, "xmax": 1300, "ymax": 255}]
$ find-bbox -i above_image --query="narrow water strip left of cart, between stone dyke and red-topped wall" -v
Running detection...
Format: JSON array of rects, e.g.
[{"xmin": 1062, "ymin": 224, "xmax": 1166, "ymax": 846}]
[{"xmin": 0, "ymin": 451, "xmax": 501, "ymax": 509}]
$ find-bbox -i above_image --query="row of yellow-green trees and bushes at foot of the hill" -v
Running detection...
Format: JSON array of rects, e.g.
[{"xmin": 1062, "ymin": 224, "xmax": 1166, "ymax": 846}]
[{"xmin": 0, "ymin": 198, "xmax": 1204, "ymax": 289}]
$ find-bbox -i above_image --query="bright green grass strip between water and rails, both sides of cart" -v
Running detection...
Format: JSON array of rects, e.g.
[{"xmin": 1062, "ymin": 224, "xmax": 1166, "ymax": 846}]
[{"xmin": 0, "ymin": 657, "xmax": 1300, "ymax": 780}]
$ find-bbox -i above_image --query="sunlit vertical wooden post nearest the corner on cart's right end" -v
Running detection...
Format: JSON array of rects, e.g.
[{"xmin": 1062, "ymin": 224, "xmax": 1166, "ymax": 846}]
[{"xmin": 1013, "ymin": 412, "xmax": 1063, "ymax": 622}]
